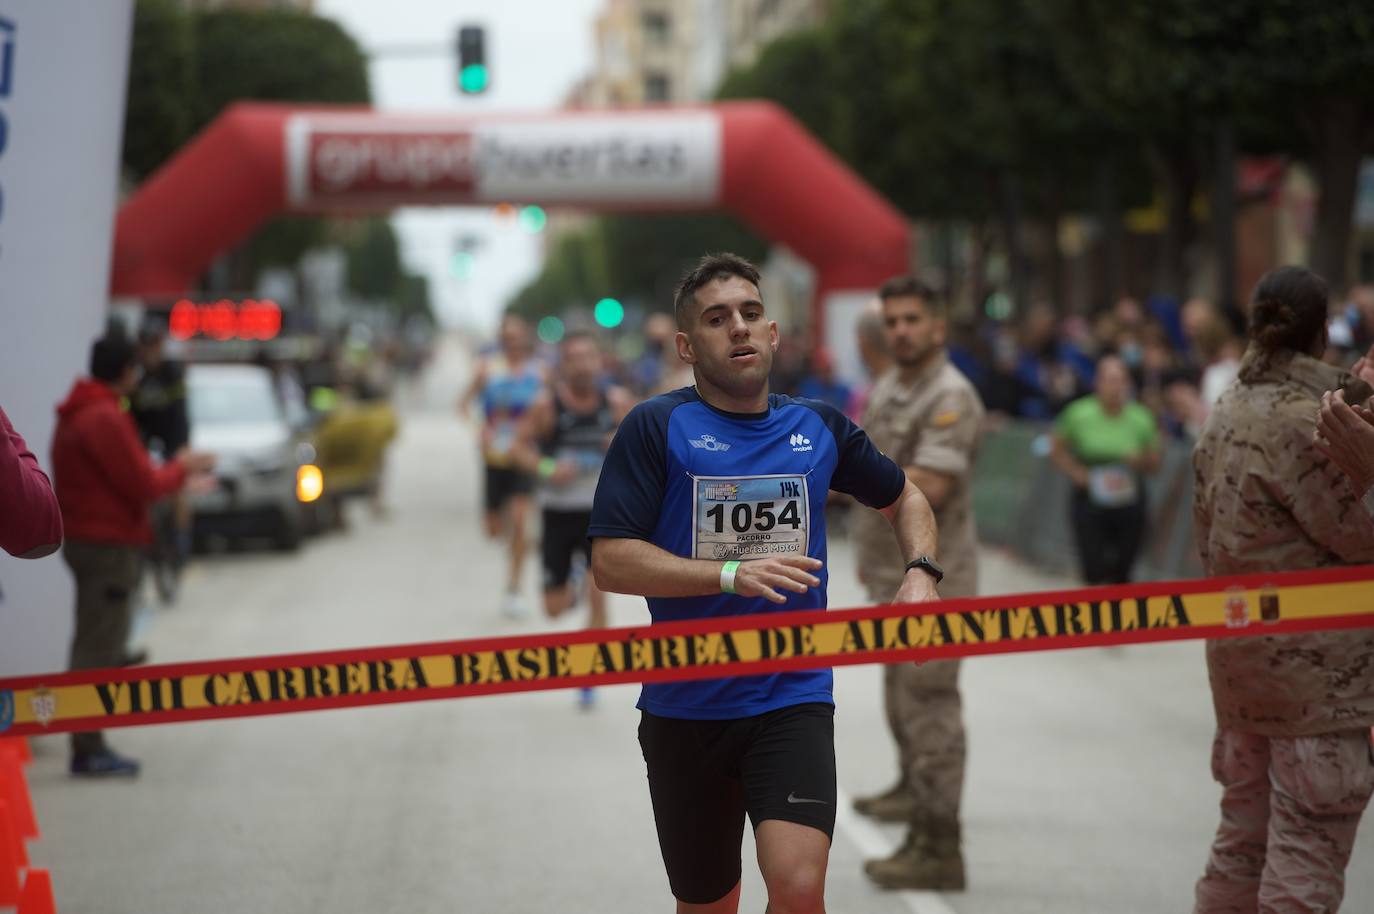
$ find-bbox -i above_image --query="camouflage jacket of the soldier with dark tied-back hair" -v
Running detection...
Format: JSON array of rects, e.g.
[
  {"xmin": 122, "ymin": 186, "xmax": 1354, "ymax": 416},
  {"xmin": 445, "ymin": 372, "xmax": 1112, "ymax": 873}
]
[{"xmin": 1193, "ymin": 346, "xmax": 1374, "ymax": 737}]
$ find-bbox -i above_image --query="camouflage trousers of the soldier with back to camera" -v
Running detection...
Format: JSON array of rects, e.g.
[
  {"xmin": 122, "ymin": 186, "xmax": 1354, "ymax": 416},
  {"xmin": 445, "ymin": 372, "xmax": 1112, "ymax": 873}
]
[{"xmin": 1193, "ymin": 728, "xmax": 1374, "ymax": 914}]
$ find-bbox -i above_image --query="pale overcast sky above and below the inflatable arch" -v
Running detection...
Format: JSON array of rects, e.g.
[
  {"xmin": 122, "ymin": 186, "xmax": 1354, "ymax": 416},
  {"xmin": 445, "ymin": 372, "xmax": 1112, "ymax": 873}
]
[{"xmin": 315, "ymin": 0, "xmax": 603, "ymax": 327}]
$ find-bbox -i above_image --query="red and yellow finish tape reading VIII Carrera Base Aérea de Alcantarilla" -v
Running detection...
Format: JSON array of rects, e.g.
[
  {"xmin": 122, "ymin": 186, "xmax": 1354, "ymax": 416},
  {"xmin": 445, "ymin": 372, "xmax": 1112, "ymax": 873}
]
[{"xmin": 0, "ymin": 566, "xmax": 1374, "ymax": 735}]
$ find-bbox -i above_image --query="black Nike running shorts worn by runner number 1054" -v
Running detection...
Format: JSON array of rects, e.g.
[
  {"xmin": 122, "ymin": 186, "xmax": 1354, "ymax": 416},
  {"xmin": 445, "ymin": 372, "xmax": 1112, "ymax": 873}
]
[{"xmin": 639, "ymin": 702, "xmax": 835, "ymax": 904}]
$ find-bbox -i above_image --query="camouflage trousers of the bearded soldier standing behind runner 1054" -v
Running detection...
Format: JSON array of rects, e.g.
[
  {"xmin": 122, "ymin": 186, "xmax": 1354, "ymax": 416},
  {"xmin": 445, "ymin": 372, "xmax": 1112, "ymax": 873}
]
[{"xmin": 882, "ymin": 660, "xmax": 965, "ymax": 822}]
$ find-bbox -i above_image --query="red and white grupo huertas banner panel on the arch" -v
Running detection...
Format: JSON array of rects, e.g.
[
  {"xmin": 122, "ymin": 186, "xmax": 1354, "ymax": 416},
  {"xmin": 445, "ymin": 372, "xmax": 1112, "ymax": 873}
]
[{"xmin": 286, "ymin": 111, "xmax": 721, "ymax": 209}]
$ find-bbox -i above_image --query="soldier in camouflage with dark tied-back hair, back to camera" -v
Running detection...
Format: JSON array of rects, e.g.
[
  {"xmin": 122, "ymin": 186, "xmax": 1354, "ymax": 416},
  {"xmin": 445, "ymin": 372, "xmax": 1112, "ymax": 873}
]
[{"xmin": 1193, "ymin": 267, "xmax": 1374, "ymax": 914}]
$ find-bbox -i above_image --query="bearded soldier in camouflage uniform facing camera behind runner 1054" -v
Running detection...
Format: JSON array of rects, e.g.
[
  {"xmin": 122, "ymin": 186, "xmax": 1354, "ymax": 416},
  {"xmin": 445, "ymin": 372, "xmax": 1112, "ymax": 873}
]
[{"xmin": 855, "ymin": 276, "xmax": 984, "ymax": 889}]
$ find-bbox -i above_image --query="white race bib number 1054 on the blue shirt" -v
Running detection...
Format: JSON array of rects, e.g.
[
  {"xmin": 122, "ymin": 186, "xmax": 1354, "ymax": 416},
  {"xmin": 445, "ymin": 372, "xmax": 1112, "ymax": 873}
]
[{"xmin": 692, "ymin": 476, "xmax": 811, "ymax": 561}]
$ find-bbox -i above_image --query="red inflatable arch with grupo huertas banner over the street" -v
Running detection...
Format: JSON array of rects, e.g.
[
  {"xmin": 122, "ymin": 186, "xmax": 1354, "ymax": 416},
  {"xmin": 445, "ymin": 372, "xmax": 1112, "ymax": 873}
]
[{"xmin": 111, "ymin": 102, "xmax": 910, "ymax": 330}]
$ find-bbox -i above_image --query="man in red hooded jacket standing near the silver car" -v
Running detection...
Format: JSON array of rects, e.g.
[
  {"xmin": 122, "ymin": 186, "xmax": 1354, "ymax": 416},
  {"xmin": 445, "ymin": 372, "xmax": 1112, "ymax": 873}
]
[{"xmin": 52, "ymin": 334, "xmax": 214, "ymax": 775}]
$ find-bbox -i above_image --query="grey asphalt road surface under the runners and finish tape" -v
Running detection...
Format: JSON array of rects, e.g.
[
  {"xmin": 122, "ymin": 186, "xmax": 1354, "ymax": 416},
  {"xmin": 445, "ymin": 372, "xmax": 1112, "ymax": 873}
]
[{"xmin": 21, "ymin": 336, "xmax": 1374, "ymax": 914}]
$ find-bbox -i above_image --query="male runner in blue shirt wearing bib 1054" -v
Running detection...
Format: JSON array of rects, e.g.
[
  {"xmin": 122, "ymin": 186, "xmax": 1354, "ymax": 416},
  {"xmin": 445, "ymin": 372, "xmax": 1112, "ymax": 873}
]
[{"xmin": 588, "ymin": 254, "xmax": 941, "ymax": 914}]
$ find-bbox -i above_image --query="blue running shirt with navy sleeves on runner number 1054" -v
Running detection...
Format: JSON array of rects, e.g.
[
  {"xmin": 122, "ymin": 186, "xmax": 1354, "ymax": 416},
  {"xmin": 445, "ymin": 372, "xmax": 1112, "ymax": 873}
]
[{"xmin": 587, "ymin": 388, "xmax": 907, "ymax": 720}]
